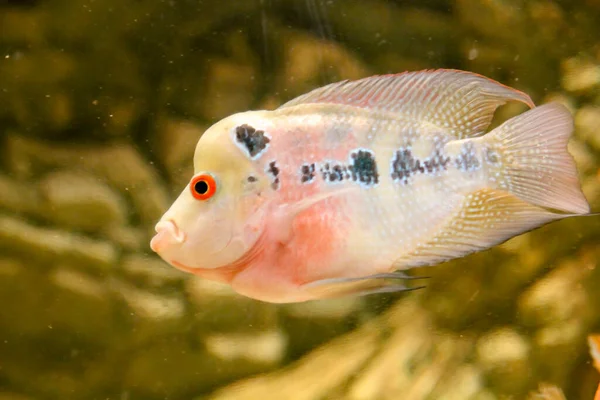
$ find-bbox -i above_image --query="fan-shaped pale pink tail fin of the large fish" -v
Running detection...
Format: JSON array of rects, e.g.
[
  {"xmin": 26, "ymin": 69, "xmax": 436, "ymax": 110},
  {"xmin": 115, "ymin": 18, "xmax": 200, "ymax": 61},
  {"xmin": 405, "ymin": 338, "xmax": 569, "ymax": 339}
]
[{"xmin": 481, "ymin": 103, "xmax": 590, "ymax": 214}]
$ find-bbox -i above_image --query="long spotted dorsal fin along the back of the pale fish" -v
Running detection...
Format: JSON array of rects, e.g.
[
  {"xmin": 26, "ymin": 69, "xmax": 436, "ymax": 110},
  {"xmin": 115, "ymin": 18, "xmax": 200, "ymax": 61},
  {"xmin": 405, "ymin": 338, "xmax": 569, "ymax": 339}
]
[{"xmin": 279, "ymin": 69, "xmax": 534, "ymax": 139}]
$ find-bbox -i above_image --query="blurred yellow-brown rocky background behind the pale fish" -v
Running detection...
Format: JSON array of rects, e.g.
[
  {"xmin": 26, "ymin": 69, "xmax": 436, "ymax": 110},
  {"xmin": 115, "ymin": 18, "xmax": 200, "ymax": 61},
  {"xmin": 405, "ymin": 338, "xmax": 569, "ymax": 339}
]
[{"xmin": 0, "ymin": 0, "xmax": 600, "ymax": 400}]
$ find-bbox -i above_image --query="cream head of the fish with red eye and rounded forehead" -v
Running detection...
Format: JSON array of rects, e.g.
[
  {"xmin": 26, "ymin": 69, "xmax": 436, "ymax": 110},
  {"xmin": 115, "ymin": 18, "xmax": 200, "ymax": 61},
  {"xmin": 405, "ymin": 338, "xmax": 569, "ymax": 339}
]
[{"xmin": 150, "ymin": 112, "xmax": 273, "ymax": 272}]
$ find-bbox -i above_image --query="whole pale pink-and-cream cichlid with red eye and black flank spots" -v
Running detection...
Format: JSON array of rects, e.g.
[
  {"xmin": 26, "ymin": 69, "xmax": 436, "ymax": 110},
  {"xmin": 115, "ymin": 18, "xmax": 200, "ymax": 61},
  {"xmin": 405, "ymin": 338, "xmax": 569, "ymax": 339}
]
[{"xmin": 151, "ymin": 70, "xmax": 589, "ymax": 303}]
